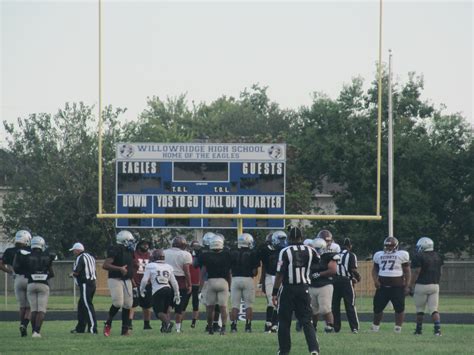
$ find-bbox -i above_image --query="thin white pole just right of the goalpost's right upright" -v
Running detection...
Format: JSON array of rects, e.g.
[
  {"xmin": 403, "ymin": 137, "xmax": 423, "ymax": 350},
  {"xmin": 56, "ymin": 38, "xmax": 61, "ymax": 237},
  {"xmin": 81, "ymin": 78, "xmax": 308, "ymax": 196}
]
[{"xmin": 388, "ymin": 50, "xmax": 393, "ymax": 237}]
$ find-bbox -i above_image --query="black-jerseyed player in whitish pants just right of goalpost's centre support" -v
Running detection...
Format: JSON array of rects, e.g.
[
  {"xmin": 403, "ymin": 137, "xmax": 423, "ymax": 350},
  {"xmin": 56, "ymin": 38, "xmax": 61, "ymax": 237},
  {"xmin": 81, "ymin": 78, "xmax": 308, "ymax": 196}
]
[{"xmin": 230, "ymin": 233, "xmax": 259, "ymax": 333}]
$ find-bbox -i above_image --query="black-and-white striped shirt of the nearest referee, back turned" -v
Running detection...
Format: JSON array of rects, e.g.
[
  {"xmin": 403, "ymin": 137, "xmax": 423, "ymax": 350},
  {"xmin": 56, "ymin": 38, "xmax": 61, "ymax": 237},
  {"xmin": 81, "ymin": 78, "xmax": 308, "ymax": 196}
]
[{"xmin": 277, "ymin": 244, "xmax": 319, "ymax": 285}]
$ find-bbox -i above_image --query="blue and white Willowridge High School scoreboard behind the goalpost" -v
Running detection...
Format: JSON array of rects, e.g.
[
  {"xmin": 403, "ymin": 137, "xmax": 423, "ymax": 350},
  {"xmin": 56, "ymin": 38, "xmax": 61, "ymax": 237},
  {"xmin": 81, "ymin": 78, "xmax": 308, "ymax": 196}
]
[{"xmin": 116, "ymin": 143, "xmax": 286, "ymax": 229}]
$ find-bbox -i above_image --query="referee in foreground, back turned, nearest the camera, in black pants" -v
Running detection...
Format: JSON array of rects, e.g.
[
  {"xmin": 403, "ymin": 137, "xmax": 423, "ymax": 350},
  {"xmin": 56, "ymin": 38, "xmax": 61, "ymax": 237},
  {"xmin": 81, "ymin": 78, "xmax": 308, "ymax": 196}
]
[{"xmin": 272, "ymin": 227, "xmax": 319, "ymax": 355}]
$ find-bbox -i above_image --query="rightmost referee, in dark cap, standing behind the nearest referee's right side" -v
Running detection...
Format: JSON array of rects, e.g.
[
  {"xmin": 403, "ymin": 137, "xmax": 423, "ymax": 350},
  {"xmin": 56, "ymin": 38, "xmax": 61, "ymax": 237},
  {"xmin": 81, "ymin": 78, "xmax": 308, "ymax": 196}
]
[{"xmin": 332, "ymin": 238, "xmax": 360, "ymax": 334}]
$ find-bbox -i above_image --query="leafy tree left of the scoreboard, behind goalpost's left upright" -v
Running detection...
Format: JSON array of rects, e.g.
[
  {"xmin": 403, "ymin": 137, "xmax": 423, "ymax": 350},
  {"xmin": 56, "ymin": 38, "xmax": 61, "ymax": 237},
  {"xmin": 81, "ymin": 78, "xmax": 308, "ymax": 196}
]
[{"xmin": 3, "ymin": 103, "xmax": 123, "ymax": 255}]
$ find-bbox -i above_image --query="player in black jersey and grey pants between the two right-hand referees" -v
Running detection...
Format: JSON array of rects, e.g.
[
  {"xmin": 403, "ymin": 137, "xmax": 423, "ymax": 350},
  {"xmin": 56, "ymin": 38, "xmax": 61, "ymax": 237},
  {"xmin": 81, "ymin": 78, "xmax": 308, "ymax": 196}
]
[{"xmin": 309, "ymin": 238, "xmax": 340, "ymax": 333}]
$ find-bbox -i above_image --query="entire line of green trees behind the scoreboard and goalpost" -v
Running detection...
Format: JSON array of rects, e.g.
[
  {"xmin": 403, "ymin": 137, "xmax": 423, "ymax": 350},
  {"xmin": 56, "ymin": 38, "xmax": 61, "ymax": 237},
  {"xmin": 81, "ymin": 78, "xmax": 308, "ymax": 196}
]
[{"xmin": 0, "ymin": 73, "xmax": 474, "ymax": 256}]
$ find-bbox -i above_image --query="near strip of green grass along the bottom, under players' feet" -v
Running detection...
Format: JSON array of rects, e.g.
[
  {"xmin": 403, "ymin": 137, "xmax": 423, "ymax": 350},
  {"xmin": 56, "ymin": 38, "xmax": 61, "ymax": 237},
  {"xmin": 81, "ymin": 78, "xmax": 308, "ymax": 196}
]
[{"xmin": 0, "ymin": 321, "xmax": 474, "ymax": 355}]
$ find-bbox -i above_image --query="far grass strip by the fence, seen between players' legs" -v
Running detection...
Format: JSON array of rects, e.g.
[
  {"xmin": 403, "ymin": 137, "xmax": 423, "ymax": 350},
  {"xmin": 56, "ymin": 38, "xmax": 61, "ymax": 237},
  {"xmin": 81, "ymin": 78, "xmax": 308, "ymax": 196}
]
[{"xmin": 0, "ymin": 296, "xmax": 474, "ymax": 313}]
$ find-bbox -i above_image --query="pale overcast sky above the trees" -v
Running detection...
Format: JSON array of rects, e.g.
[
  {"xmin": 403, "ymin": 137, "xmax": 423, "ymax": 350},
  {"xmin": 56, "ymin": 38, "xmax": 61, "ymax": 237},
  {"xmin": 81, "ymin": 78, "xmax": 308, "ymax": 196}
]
[{"xmin": 0, "ymin": 0, "xmax": 474, "ymax": 146}]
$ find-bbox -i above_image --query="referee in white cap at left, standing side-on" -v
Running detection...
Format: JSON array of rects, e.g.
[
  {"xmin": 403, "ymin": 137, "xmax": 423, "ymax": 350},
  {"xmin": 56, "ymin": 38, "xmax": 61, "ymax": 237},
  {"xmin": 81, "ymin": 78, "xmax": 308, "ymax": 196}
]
[{"xmin": 69, "ymin": 243, "xmax": 97, "ymax": 334}]
